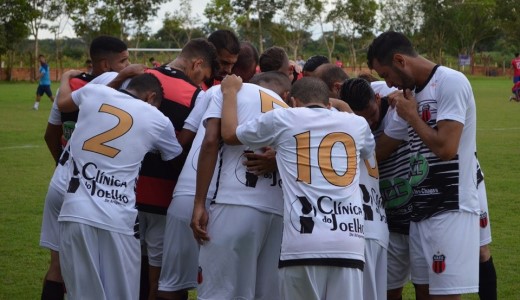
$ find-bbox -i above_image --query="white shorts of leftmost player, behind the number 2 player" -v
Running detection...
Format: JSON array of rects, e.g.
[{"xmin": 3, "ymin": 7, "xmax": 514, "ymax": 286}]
[{"xmin": 40, "ymin": 185, "xmax": 64, "ymax": 251}]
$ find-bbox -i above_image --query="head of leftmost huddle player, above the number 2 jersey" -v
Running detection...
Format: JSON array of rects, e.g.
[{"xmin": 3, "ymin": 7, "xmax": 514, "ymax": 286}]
[{"xmin": 90, "ymin": 35, "xmax": 130, "ymax": 76}]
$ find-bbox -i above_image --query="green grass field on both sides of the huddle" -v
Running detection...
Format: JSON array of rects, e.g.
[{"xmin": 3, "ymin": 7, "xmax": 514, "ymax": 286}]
[{"xmin": 0, "ymin": 77, "xmax": 520, "ymax": 300}]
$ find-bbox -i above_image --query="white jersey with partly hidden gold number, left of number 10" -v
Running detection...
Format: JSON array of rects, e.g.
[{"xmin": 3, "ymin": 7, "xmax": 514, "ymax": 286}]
[{"xmin": 204, "ymin": 83, "xmax": 287, "ymax": 215}]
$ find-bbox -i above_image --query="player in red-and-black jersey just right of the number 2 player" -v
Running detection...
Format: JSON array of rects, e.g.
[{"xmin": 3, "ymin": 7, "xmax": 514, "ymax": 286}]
[{"xmin": 136, "ymin": 38, "xmax": 218, "ymax": 299}]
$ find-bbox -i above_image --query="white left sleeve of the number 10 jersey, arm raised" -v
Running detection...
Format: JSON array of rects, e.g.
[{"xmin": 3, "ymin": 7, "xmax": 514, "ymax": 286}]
[{"xmin": 236, "ymin": 109, "xmax": 281, "ymax": 149}]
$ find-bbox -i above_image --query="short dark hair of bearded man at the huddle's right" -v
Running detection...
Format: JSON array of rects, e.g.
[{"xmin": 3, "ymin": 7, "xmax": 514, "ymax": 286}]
[{"xmin": 367, "ymin": 31, "xmax": 417, "ymax": 69}]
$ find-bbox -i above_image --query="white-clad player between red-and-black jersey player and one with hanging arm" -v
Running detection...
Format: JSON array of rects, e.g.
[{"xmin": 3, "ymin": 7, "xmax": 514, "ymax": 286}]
[{"xmin": 157, "ymin": 42, "xmax": 260, "ymax": 300}]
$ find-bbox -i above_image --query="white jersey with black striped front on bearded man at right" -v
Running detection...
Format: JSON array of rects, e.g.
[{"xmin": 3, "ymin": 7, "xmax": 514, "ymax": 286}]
[{"xmin": 408, "ymin": 66, "xmax": 479, "ymax": 222}]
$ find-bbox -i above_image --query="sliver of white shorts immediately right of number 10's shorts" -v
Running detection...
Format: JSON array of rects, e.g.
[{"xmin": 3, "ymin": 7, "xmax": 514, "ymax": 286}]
[{"xmin": 363, "ymin": 239, "xmax": 387, "ymax": 299}]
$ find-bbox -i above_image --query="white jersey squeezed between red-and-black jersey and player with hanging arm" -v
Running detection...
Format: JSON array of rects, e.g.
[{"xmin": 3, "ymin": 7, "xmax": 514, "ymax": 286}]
[{"xmin": 173, "ymin": 85, "xmax": 214, "ymax": 197}]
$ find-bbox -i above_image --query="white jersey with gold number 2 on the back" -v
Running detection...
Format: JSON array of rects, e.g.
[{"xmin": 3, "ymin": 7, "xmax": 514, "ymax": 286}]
[{"xmin": 58, "ymin": 85, "xmax": 182, "ymax": 235}]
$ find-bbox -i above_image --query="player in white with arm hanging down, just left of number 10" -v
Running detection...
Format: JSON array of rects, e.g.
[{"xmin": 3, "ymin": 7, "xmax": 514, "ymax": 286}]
[{"xmin": 191, "ymin": 72, "xmax": 290, "ymax": 299}]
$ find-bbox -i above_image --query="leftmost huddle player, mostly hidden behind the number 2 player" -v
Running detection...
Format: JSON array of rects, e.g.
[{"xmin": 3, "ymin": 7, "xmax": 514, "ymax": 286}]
[{"xmin": 40, "ymin": 36, "xmax": 129, "ymax": 299}]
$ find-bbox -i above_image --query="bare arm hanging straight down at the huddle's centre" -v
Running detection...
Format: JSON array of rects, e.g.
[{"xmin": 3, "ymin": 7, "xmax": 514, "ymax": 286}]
[{"xmin": 191, "ymin": 118, "xmax": 220, "ymax": 244}]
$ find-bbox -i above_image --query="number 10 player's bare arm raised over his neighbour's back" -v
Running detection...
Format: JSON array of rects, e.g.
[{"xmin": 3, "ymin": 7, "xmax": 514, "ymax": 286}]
[{"xmin": 220, "ymin": 75, "xmax": 242, "ymax": 145}]
